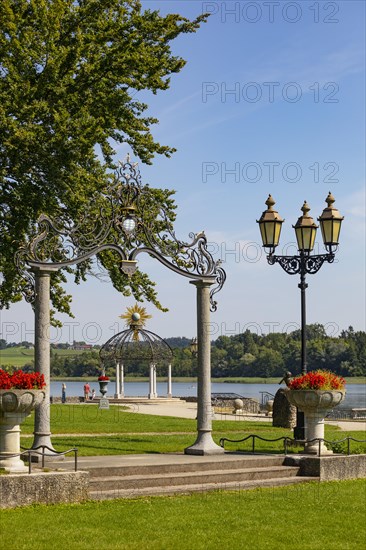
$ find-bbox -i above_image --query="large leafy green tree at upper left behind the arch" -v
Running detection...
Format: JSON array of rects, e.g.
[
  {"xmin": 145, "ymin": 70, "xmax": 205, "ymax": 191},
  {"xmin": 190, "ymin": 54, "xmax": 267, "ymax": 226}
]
[{"xmin": 0, "ymin": 0, "xmax": 205, "ymax": 312}]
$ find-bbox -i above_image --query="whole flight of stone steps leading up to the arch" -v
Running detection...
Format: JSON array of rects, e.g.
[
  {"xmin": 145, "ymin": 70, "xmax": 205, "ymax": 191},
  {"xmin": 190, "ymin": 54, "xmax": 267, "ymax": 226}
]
[{"xmin": 63, "ymin": 452, "xmax": 318, "ymax": 500}]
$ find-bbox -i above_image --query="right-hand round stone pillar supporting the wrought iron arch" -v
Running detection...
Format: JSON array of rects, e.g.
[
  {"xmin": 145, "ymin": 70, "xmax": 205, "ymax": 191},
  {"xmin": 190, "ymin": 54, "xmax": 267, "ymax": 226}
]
[{"xmin": 184, "ymin": 279, "xmax": 224, "ymax": 455}]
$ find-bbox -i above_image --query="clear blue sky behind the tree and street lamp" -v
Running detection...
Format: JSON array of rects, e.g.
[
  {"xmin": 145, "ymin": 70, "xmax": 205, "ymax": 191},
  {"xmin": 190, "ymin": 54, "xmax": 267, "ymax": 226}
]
[{"xmin": 1, "ymin": 0, "xmax": 365, "ymax": 343}]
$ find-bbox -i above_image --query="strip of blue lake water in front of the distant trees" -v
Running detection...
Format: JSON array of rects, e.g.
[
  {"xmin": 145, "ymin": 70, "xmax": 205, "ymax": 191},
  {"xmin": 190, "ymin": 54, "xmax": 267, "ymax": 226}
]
[{"xmin": 51, "ymin": 380, "xmax": 366, "ymax": 409}]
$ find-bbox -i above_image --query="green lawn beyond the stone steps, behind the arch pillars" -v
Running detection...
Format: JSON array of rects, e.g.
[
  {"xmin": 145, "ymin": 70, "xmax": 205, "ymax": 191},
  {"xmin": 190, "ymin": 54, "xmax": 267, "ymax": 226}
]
[{"xmin": 21, "ymin": 404, "xmax": 366, "ymax": 456}]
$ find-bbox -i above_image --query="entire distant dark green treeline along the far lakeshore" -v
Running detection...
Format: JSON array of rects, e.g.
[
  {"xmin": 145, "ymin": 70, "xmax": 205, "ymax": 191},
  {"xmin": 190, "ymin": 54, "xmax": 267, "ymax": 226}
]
[{"xmin": 2, "ymin": 324, "xmax": 366, "ymax": 377}]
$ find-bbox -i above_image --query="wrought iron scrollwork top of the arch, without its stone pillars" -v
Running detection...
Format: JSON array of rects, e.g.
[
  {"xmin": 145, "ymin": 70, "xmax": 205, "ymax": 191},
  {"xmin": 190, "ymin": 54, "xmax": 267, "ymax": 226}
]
[{"xmin": 15, "ymin": 157, "xmax": 226, "ymax": 311}]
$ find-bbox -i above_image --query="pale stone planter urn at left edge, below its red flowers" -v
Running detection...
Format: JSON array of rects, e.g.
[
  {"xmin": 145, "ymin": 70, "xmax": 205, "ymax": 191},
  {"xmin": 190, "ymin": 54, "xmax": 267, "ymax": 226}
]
[{"xmin": 0, "ymin": 389, "xmax": 46, "ymax": 473}]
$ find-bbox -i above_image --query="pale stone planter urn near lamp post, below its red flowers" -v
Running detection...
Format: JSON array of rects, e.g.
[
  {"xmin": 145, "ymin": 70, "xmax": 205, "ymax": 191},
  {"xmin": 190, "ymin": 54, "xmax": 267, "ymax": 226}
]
[{"xmin": 286, "ymin": 389, "xmax": 346, "ymax": 454}]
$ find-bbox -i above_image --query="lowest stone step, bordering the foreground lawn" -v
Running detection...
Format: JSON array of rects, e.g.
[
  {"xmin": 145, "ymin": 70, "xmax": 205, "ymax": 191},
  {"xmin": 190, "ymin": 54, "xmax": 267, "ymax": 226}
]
[{"xmin": 89, "ymin": 476, "xmax": 319, "ymax": 500}]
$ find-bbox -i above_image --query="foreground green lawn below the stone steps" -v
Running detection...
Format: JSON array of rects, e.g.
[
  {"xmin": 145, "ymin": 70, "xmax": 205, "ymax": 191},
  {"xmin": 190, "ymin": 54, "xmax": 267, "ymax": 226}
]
[{"xmin": 1, "ymin": 480, "xmax": 366, "ymax": 550}]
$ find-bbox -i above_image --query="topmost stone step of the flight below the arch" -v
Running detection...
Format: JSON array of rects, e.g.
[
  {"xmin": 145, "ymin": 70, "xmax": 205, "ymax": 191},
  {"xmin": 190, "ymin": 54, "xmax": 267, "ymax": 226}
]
[{"xmin": 86, "ymin": 455, "xmax": 284, "ymax": 478}]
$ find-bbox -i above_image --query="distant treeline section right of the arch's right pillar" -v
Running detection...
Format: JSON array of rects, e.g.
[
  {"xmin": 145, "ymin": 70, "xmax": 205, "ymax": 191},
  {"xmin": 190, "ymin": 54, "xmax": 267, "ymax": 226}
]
[{"xmin": 212, "ymin": 323, "xmax": 366, "ymax": 378}]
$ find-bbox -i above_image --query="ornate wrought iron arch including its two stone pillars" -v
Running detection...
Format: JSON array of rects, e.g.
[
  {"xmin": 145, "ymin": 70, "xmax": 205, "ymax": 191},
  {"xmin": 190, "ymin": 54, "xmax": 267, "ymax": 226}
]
[{"xmin": 15, "ymin": 158, "xmax": 226, "ymax": 454}]
